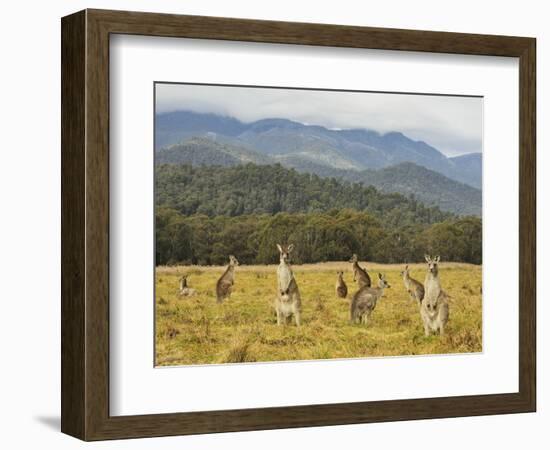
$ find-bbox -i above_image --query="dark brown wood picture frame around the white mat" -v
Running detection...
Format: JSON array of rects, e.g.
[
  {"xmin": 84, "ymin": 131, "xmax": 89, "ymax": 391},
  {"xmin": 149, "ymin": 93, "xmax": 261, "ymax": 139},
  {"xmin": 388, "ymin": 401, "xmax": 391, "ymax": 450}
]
[{"xmin": 61, "ymin": 10, "xmax": 536, "ymax": 440}]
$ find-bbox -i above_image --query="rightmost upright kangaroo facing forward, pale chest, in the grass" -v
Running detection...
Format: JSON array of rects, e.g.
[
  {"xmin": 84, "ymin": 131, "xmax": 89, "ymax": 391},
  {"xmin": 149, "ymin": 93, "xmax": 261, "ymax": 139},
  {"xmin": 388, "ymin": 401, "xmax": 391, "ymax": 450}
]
[{"xmin": 420, "ymin": 255, "xmax": 449, "ymax": 336}]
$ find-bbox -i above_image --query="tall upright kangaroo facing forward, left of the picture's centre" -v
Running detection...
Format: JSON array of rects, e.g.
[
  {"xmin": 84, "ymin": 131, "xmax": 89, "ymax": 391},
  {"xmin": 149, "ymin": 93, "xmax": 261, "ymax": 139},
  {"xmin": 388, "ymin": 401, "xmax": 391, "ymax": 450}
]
[{"xmin": 275, "ymin": 244, "xmax": 302, "ymax": 327}]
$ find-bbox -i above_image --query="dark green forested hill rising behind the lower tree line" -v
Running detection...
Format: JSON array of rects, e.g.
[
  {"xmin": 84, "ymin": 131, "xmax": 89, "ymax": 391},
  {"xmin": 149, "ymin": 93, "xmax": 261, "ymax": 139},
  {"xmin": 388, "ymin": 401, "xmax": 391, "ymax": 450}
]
[{"xmin": 155, "ymin": 164, "xmax": 454, "ymax": 227}]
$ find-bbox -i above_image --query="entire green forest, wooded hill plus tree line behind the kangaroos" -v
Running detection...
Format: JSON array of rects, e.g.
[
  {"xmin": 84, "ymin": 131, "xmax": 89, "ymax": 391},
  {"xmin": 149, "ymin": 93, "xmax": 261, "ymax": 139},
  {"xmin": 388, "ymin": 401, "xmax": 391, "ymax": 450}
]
[{"xmin": 155, "ymin": 164, "xmax": 482, "ymax": 264}]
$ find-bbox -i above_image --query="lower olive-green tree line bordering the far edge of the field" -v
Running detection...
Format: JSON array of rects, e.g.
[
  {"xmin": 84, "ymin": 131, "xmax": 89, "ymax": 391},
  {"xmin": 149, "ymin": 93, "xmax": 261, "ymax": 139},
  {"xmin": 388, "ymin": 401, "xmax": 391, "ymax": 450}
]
[{"xmin": 155, "ymin": 206, "xmax": 482, "ymax": 265}]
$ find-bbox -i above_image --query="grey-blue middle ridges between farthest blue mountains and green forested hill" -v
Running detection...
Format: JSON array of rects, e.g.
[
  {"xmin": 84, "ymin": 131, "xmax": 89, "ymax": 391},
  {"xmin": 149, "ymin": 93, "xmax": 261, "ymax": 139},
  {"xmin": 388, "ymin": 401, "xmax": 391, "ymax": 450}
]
[{"xmin": 156, "ymin": 137, "xmax": 481, "ymax": 216}]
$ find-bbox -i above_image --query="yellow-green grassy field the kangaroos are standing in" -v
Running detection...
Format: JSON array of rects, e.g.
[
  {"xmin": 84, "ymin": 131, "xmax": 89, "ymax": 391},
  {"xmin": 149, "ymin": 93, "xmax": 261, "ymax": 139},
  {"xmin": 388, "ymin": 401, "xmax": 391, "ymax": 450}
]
[{"xmin": 155, "ymin": 262, "xmax": 482, "ymax": 366}]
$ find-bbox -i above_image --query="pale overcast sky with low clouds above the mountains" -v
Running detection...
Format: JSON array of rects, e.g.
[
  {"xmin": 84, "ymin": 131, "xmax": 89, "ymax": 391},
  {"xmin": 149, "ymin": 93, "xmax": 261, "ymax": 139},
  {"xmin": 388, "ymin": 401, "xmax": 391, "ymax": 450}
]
[{"xmin": 156, "ymin": 84, "xmax": 483, "ymax": 156}]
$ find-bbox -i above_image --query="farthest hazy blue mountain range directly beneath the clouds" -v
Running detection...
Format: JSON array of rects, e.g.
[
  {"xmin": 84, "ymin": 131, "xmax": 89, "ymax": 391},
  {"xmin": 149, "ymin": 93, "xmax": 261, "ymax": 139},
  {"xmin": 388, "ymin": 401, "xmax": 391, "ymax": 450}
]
[{"xmin": 155, "ymin": 111, "xmax": 481, "ymax": 188}]
